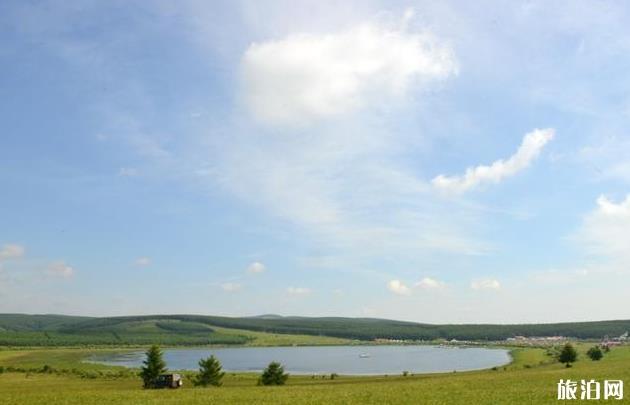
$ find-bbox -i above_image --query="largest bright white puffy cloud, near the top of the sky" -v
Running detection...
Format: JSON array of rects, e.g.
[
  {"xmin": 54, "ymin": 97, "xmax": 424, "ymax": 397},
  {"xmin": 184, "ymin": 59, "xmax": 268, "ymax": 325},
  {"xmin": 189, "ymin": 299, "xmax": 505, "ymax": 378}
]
[{"xmin": 242, "ymin": 16, "xmax": 457, "ymax": 126}]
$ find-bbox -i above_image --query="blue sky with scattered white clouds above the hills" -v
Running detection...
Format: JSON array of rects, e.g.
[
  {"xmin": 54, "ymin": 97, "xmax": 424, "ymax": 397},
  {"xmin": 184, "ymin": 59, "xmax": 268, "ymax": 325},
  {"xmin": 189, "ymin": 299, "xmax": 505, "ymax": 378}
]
[{"xmin": 0, "ymin": 0, "xmax": 630, "ymax": 323}]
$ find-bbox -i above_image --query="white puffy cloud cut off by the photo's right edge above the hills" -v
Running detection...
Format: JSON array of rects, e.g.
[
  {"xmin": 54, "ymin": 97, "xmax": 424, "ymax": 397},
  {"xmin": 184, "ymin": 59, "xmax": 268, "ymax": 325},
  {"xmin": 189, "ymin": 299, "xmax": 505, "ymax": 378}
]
[{"xmin": 576, "ymin": 194, "xmax": 630, "ymax": 263}]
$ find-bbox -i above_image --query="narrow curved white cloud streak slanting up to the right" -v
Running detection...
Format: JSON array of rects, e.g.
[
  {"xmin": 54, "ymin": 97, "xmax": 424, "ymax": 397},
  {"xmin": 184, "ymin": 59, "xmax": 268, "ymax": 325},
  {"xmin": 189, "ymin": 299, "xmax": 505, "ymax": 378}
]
[{"xmin": 431, "ymin": 128, "xmax": 554, "ymax": 193}]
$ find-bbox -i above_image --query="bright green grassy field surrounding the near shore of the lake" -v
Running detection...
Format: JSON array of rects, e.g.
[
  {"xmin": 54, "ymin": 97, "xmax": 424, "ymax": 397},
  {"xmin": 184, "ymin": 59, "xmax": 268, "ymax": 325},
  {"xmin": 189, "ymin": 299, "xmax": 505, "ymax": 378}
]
[{"xmin": 0, "ymin": 345, "xmax": 630, "ymax": 405}]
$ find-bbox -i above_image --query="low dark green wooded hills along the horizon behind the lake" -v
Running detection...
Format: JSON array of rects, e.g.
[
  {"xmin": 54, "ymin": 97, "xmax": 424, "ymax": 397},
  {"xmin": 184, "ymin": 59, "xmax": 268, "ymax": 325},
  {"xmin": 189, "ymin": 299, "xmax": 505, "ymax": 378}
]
[{"xmin": 0, "ymin": 314, "xmax": 630, "ymax": 345}]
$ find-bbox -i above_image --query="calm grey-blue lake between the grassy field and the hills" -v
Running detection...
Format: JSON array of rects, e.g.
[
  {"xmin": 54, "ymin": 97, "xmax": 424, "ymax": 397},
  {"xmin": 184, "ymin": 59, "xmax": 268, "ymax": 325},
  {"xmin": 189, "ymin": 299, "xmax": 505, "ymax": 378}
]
[{"xmin": 90, "ymin": 346, "xmax": 511, "ymax": 375}]
